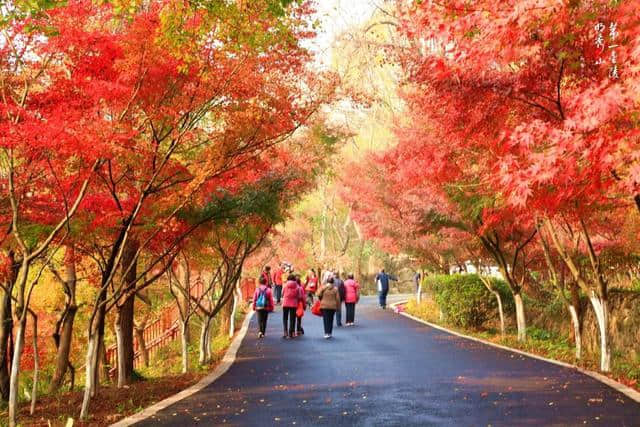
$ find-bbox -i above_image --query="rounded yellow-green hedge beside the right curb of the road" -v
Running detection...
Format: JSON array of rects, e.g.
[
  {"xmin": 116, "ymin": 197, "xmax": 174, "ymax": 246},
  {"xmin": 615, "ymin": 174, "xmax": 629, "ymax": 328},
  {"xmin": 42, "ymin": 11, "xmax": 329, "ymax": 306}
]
[{"xmin": 425, "ymin": 274, "xmax": 514, "ymax": 328}]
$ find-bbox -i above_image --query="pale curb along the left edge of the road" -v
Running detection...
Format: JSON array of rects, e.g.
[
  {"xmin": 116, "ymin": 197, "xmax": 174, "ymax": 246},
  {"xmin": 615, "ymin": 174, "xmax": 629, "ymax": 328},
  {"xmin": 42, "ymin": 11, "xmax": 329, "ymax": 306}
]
[{"xmin": 110, "ymin": 310, "xmax": 254, "ymax": 427}]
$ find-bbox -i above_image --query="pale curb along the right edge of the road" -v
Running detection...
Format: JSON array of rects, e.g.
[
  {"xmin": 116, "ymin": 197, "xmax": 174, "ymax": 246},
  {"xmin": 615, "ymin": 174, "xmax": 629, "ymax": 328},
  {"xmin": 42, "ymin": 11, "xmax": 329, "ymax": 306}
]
[{"xmin": 390, "ymin": 301, "xmax": 640, "ymax": 403}]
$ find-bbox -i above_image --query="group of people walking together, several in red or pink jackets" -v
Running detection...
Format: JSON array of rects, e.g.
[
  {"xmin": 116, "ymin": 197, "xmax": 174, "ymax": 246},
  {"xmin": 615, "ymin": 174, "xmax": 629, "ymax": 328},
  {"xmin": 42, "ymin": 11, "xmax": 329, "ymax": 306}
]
[{"xmin": 253, "ymin": 262, "xmax": 360, "ymax": 339}]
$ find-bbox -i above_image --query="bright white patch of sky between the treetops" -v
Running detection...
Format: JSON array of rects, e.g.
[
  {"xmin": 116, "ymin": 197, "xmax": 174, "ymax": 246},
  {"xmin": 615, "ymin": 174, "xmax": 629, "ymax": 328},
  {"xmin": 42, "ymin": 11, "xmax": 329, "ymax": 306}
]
[{"xmin": 310, "ymin": 0, "xmax": 384, "ymax": 65}]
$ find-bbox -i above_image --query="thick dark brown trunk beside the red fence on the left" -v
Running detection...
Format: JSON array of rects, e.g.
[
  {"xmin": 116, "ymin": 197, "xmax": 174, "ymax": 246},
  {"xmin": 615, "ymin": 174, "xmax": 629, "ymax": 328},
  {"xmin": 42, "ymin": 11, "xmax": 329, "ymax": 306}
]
[{"xmin": 116, "ymin": 239, "xmax": 138, "ymax": 388}]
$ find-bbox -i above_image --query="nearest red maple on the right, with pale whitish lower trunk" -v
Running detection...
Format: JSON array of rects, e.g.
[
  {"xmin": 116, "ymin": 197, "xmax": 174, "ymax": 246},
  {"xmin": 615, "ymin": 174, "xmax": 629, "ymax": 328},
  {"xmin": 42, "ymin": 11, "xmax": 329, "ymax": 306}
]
[{"xmin": 401, "ymin": 1, "xmax": 640, "ymax": 371}]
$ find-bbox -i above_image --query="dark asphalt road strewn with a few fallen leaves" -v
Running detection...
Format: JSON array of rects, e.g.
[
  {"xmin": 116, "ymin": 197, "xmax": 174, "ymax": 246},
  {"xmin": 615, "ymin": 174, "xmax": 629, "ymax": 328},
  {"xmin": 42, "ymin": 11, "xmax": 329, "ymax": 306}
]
[{"xmin": 139, "ymin": 298, "xmax": 640, "ymax": 426}]
